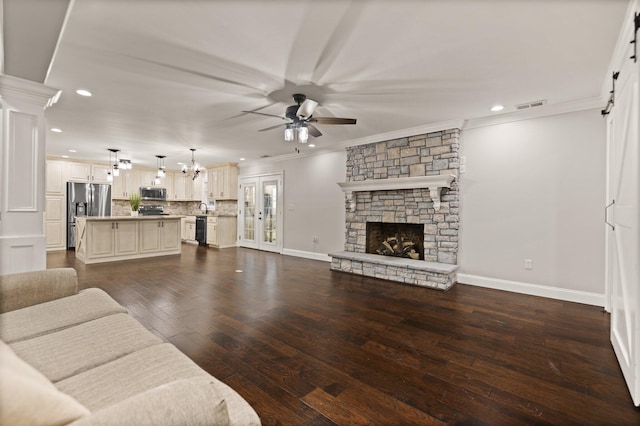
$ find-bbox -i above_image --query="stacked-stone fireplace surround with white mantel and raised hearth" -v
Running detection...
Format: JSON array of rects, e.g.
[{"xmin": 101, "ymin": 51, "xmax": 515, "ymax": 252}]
[{"xmin": 330, "ymin": 129, "xmax": 460, "ymax": 290}]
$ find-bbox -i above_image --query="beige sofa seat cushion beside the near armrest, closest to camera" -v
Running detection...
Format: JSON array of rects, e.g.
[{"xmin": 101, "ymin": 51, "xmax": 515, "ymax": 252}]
[{"xmin": 56, "ymin": 343, "xmax": 260, "ymax": 425}]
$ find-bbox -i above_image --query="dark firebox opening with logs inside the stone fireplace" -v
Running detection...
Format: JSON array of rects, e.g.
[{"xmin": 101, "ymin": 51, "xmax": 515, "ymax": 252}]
[{"xmin": 366, "ymin": 222, "xmax": 424, "ymax": 260}]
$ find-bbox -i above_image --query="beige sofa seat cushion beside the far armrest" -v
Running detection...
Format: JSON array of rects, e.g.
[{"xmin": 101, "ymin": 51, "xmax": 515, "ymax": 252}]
[{"xmin": 0, "ymin": 288, "xmax": 126, "ymax": 343}]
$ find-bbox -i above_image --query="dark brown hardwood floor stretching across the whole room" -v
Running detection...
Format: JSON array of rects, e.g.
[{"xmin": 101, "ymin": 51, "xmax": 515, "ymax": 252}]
[{"xmin": 47, "ymin": 245, "xmax": 640, "ymax": 425}]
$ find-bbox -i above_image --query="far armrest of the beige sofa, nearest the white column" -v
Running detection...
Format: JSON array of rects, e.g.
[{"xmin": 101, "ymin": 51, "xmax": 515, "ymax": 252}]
[{"xmin": 0, "ymin": 268, "xmax": 78, "ymax": 313}]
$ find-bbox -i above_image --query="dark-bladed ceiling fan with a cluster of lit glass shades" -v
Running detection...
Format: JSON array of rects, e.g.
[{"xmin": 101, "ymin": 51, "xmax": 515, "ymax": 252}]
[{"xmin": 242, "ymin": 93, "xmax": 356, "ymax": 143}]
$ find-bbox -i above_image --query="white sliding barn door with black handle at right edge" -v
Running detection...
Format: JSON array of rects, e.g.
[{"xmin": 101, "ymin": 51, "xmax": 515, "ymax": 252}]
[{"xmin": 606, "ymin": 54, "xmax": 640, "ymax": 406}]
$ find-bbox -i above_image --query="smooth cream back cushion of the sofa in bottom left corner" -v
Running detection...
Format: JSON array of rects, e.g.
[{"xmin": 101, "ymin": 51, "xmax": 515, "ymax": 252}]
[{"xmin": 0, "ymin": 341, "xmax": 91, "ymax": 425}]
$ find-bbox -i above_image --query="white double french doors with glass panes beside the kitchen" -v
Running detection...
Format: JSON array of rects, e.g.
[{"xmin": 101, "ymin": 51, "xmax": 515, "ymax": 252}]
[{"xmin": 238, "ymin": 173, "xmax": 283, "ymax": 253}]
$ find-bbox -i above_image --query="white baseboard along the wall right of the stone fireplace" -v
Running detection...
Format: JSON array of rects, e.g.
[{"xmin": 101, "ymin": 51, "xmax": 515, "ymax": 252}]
[{"xmin": 458, "ymin": 274, "xmax": 605, "ymax": 306}]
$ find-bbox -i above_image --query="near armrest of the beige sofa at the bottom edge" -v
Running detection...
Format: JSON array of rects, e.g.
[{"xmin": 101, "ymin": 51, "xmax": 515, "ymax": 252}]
[{"xmin": 69, "ymin": 377, "xmax": 229, "ymax": 426}]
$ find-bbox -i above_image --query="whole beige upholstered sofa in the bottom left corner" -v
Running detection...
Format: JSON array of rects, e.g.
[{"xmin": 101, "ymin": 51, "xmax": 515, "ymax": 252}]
[{"xmin": 0, "ymin": 268, "xmax": 260, "ymax": 426}]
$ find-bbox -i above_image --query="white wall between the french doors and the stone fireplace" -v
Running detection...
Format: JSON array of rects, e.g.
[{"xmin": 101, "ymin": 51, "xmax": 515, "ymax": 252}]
[{"xmin": 240, "ymin": 151, "xmax": 346, "ymax": 261}]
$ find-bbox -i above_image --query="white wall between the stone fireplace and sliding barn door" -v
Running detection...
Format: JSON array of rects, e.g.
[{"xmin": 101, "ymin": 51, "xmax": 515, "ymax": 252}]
[{"xmin": 458, "ymin": 110, "xmax": 606, "ymax": 305}]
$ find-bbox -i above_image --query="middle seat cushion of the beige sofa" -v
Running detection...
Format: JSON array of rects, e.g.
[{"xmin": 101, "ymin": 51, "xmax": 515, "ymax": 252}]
[{"xmin": 11, "ymin": 314, "xmax": 162, "ymax": 382}]
